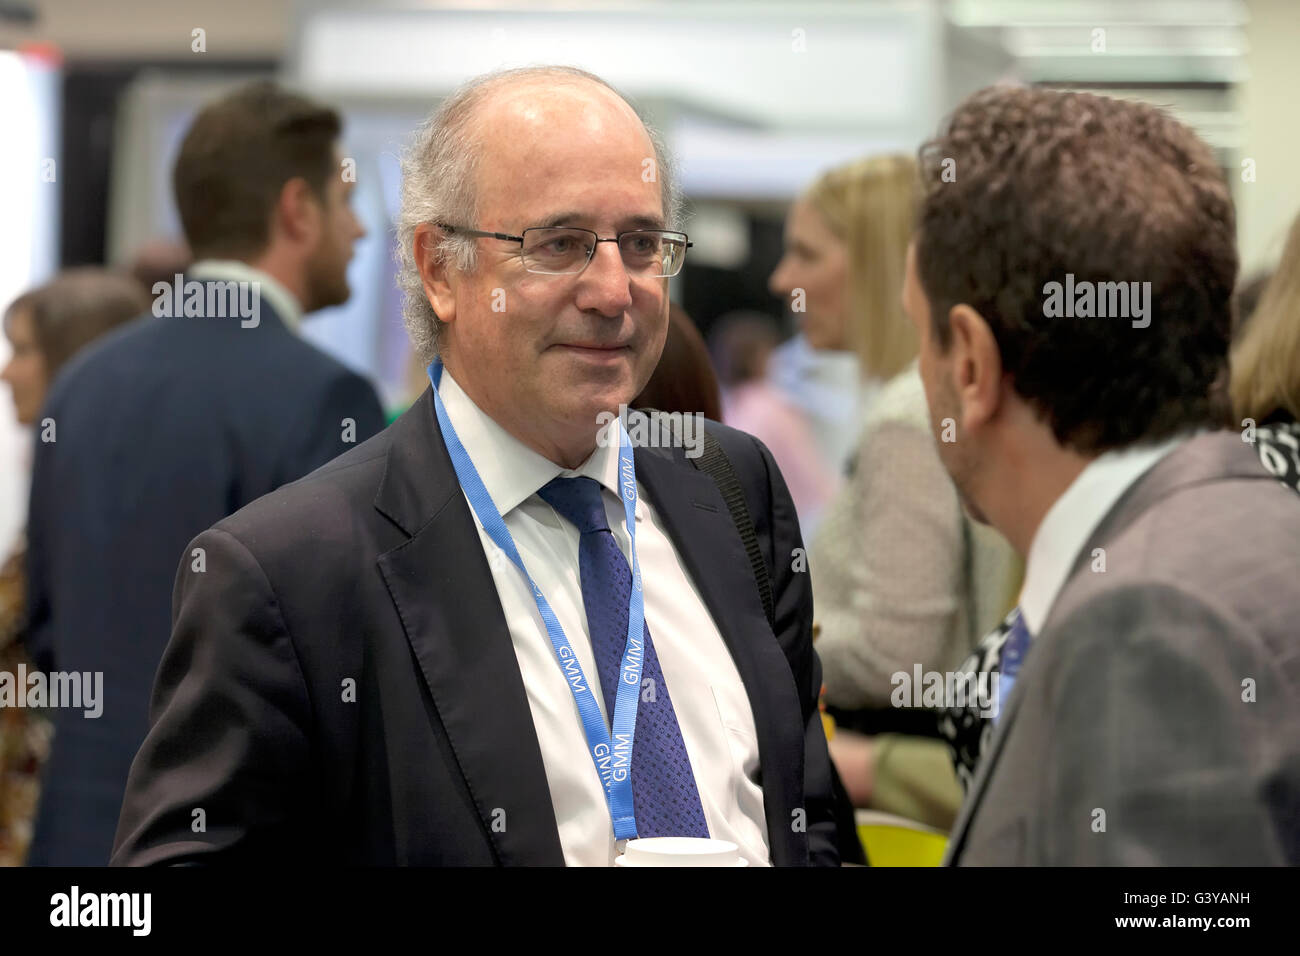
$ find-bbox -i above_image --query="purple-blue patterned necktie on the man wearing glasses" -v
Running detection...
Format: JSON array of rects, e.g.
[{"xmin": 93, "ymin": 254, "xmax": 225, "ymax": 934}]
[{"xmin": 538, "ymin": 477, "xmax": 709, "ymax": 838}]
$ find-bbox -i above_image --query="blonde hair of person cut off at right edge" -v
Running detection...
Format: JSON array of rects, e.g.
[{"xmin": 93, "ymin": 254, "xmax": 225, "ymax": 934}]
[{"xmin": 1229, "ymin": 216, "xmax": 1300, "ymax": 421}]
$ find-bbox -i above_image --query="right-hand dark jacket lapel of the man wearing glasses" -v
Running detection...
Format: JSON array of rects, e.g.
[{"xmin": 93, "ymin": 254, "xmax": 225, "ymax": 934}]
[{"xmin": 636, "ymin": 447, "xmax": 807, "ymax": 866}]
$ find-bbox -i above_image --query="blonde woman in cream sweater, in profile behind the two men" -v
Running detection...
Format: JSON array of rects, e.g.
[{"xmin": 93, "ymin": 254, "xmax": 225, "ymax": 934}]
[{"xmin": 771, "ymin": 155, "xmax": 1019, "ymax": 829}]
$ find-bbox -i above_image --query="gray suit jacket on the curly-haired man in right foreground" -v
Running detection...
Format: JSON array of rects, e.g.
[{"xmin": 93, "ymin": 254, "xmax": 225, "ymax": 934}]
[{"xmin": 946, "ymin": 432, "xmax": 1300, "ymax": 865}]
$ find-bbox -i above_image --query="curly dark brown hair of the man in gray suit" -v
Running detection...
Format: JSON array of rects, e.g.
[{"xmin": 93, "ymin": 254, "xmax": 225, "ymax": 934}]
[{"xmin": 917, "ymin": 87, "xmax": 1238, "ymax": 454}]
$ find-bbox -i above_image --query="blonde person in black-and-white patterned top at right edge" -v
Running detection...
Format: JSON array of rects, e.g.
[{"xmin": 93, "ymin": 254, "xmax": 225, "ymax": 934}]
[{"xmin": 1229, "ymin": 216, "xmax": 1300, "ymax": 492}]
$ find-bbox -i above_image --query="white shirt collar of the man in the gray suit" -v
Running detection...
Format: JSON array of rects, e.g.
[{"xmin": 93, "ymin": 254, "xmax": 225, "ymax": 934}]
[{"xmin": 1021, "ymin": 434, "xmax": 1191, "ymax": 635}]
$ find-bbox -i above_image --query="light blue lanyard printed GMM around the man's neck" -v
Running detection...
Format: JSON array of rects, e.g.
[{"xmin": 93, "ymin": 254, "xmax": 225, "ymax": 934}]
[{"xmin": 429, "ymin": 359, "xmax": 645, "ymax": 840}]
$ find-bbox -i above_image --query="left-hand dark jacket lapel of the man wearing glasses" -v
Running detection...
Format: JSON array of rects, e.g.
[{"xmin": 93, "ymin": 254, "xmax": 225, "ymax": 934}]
[{"xmin": 374, "ymin": 389, "xmax": 564, "ymax": 865}]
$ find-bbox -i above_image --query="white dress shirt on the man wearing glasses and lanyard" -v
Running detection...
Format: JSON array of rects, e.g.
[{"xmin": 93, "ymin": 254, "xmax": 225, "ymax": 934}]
[{"xmin": 438, "ymin": 369, "xmax": 770, "ymax": 866}]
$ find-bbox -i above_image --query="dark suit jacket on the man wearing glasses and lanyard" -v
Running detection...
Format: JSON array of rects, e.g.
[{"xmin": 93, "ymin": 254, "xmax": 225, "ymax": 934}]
[{"xmin": 113, "ymin": 390, "xmax": 837, "ymax": 865}]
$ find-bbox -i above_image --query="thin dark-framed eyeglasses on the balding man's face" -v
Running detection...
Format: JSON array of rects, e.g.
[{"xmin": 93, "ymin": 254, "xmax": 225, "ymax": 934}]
[{"xmin": 438, "ymin": 222, "xmax": 694, "ymax": 278}]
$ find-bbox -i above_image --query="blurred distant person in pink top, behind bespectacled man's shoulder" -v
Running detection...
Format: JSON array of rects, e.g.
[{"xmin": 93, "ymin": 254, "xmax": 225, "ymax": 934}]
[{"xmin": 712, "ymin": 312, "xmax": 837, "ymax": 537}]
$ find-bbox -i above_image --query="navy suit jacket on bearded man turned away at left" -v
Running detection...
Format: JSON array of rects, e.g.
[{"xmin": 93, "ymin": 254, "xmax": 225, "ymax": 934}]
[{"xmin": 26, "ymin": 291, "xmax": 384, "ymax": 866}]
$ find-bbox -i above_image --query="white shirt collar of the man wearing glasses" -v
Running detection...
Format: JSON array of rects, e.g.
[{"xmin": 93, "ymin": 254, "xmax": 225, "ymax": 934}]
[{"xmin": 438, "ymin": 368, "xmax": 645, "ymax": 520}]
